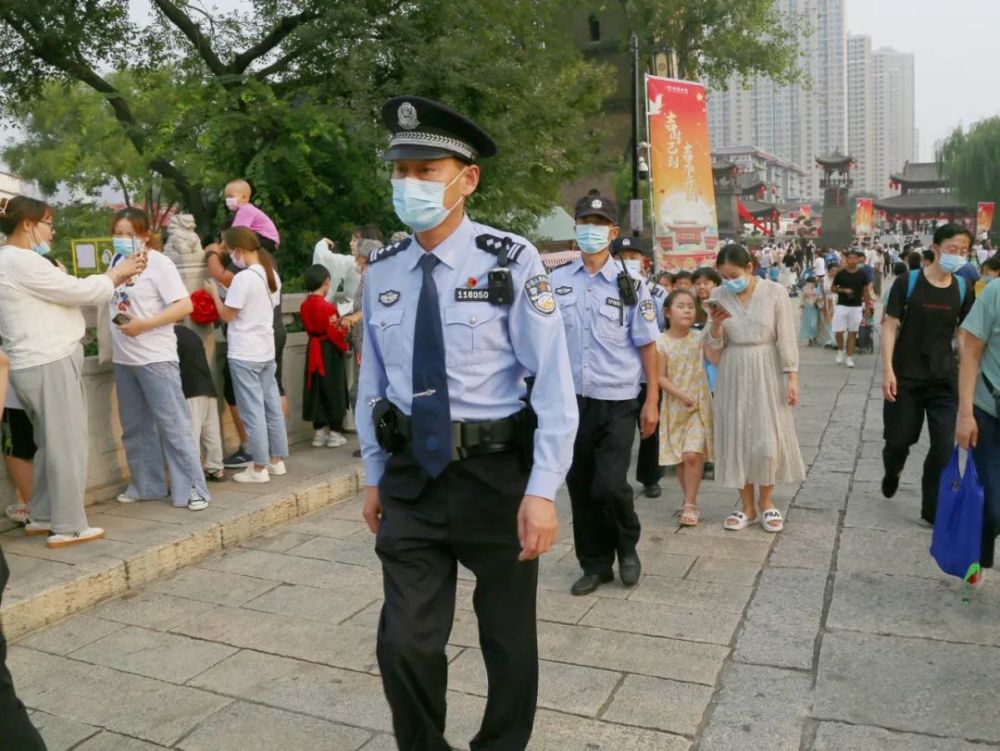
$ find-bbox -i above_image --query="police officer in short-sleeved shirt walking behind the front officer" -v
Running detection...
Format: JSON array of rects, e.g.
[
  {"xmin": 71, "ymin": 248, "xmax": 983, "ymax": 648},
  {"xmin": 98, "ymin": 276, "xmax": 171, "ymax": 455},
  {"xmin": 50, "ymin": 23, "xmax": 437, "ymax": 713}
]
[{"xmin": 552, "ymin": 191, "xmax": 660, "ymax": 595}]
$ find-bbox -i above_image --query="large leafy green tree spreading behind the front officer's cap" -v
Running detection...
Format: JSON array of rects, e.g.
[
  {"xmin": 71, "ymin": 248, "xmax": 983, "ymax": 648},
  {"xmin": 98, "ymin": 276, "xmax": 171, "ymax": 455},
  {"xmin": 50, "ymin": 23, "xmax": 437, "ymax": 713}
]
[{"xmin": 0, "ymin": 0, "xmax": 609, "ymax": 264}]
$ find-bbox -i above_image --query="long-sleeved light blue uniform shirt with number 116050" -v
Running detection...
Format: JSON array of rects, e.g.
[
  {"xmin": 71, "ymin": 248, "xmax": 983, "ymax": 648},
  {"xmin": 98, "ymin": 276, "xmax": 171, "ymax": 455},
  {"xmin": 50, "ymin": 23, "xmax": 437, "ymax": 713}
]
[{"xmin": 356, "ymin": 217, "xmax": 578, "ymax": 499}]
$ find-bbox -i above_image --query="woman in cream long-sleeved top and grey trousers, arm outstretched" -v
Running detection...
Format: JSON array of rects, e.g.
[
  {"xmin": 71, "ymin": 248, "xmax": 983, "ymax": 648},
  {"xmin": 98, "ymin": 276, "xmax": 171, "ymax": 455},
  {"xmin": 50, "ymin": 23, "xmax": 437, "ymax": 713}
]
[{"xmin": 0, "ymin": 196, "xmax": 146, "ymax": 548}]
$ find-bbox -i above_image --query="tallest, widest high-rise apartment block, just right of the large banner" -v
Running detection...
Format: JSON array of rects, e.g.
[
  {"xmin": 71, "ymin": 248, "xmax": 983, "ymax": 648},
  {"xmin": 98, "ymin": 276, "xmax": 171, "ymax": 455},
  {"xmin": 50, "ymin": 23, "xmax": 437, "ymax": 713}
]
[{"xmin": 708, "ymin": 0, "xmax": 848, "ymax": 198}]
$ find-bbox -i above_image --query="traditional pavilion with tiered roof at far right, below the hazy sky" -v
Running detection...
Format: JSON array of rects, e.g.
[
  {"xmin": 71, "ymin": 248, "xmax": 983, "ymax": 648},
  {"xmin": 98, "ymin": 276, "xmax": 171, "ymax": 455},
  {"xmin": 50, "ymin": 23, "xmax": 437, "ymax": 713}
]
[{"xmin": 875, "ymin": 162, "xmax": 972, "ymax": 224}]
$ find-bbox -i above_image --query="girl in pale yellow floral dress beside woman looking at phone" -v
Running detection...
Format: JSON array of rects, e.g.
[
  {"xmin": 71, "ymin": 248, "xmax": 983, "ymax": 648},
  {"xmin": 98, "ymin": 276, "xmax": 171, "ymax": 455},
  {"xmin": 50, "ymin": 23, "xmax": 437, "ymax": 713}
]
[{"xmin": 656, "ymin": 290, "xmax": 713, "ymax": 527}]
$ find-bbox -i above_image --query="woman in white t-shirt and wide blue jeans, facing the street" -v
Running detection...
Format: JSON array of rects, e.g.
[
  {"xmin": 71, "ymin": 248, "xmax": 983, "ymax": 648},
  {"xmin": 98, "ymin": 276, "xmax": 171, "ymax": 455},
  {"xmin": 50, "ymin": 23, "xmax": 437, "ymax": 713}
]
[{"xmin": 110, "ymin": 208, "xmax": 209, "ymax": 511}]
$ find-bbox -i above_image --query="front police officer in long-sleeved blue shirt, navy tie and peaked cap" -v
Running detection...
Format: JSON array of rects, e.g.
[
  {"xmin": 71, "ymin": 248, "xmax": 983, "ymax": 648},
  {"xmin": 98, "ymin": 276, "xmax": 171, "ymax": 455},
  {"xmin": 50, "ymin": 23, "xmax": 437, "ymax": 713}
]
[{"xmin": 357, "ymin": 97, "xmax": 577, "ymax": 751}]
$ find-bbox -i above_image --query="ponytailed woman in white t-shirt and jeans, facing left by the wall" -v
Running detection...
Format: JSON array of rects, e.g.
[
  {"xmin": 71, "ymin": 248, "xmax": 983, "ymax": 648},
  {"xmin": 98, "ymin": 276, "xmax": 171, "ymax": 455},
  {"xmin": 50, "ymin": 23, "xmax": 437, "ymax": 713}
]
[{"xmin": 205, "ymin": 227, "xmax": 288, "ymax": 482}]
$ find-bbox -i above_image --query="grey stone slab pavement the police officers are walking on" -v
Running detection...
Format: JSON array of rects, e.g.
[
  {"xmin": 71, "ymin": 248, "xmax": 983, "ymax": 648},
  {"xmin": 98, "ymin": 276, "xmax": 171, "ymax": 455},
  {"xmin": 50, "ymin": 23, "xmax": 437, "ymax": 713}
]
[{"xmin": 11, "ymin": 342, "xmax": 1000, "ymax": 751}]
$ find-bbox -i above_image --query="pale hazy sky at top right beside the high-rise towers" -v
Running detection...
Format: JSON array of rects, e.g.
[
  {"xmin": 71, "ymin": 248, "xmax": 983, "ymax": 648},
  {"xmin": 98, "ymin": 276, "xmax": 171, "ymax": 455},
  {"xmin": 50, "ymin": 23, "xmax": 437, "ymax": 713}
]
[{"xmin": 846, "ymin": 0, "xmax": 1000, "ymax": 161}]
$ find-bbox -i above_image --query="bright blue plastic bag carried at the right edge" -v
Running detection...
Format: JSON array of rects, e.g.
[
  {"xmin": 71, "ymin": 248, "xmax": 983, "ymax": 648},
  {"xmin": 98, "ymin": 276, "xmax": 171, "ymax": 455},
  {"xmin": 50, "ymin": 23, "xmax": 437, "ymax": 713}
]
[{"xmin": 931, "ymin": 446, "xmax": 983, "ymax": 583}]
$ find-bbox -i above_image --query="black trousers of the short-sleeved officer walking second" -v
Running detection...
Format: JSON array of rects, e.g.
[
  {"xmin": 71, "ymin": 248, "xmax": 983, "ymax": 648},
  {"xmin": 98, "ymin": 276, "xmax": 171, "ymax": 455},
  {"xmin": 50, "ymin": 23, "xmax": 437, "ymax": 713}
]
[{"xmin": 566, "ymin": 396, "xmax": 641, "ymax": 574}]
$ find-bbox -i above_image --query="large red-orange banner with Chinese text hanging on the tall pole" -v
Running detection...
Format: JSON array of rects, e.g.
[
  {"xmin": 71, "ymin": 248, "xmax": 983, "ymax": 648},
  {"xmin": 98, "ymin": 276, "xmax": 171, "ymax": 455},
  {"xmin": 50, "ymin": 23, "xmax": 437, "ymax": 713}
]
[{"xmin": 646, "ymin": 76, "xmax": 719, "ymax": 271}]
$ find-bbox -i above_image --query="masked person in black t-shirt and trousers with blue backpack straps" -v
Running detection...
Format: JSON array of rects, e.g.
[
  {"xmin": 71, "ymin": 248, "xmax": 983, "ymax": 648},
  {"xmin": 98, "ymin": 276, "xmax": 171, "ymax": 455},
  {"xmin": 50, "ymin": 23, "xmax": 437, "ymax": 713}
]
[{"xmin": 882, "ymin": 223, "xmax": 974, "ymax": 524}]
